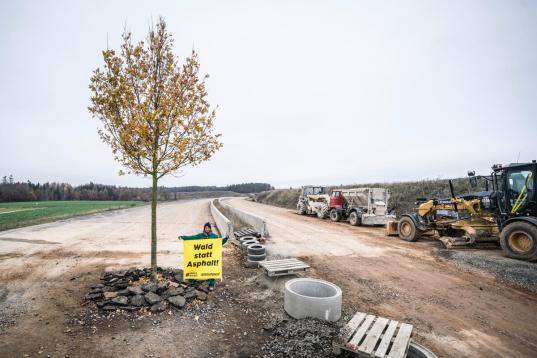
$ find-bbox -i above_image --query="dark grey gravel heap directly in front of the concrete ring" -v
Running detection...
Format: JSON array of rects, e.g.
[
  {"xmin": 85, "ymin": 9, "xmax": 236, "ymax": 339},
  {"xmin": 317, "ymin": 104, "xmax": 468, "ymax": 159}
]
[{"xmin": 261, "ymin": 318, "xmax": 338, "ymax": 358}]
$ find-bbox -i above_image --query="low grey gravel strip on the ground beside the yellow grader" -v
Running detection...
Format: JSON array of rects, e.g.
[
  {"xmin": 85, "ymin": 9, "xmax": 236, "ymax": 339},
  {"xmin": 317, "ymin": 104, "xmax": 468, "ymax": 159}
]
[{"xmin": 437, "ymin": 250, "xmax": 537, "ymax": 292}]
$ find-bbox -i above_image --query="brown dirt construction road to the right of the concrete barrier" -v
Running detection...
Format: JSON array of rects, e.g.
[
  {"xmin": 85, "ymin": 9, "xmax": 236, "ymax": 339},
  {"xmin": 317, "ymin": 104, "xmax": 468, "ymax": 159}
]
[{"xmin": 228, "ymin": 199, "xmax": 537, "ymax": 357}]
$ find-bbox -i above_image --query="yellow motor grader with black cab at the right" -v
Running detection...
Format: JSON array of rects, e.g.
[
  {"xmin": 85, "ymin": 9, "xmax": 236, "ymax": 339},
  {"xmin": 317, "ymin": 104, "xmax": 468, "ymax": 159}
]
[{"xmin": 388, "ymin": 160, "xmax": 537, "ymax": 261}]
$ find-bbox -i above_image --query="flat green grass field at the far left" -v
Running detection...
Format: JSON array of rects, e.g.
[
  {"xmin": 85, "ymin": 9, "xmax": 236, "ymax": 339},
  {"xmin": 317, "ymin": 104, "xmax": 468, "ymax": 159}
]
[{"xmin": 0, "ymin": 201, "xmax": 143, "ymax": 231}]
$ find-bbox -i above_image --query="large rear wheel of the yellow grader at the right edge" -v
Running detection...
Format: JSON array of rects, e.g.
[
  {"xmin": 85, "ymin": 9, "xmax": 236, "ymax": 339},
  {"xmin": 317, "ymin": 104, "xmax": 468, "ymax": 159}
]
[{"xmin": 500, "ymin": 221, "xmax": 537, "ymax": 261}]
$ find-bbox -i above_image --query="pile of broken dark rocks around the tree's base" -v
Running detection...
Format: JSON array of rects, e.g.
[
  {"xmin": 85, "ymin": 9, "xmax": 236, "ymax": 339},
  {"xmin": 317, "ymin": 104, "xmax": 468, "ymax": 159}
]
[{"xmin": 86, "ymin": 267, "xmax": 209, "ymax": 312}]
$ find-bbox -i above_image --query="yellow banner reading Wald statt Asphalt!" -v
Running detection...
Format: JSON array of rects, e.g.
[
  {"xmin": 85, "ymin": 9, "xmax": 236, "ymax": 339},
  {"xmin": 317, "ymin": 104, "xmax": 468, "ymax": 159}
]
[{"xmin": 183, "ymin": 238, "xmax": 222, "ymax": 280}]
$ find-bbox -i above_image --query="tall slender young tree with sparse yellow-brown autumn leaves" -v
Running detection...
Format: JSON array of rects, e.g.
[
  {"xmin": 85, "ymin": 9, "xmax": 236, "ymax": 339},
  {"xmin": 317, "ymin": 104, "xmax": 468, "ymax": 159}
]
[{"xmin": 88, "ymin": 18, "xmax": 222, "ymax": 278}]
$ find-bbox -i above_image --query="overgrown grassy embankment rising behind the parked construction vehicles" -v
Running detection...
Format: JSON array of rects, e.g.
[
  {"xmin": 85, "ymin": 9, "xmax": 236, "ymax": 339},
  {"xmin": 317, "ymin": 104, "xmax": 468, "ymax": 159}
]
[{"xmin": 256, "ymin": 178, "xmax": 485, "ymax": 215}]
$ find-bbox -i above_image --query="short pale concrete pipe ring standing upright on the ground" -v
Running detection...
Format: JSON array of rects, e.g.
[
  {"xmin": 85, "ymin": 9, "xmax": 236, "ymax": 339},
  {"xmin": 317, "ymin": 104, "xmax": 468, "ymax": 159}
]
[{"xmin": 283, "ymin": 278, "xmax": 342, "ymax": 322}]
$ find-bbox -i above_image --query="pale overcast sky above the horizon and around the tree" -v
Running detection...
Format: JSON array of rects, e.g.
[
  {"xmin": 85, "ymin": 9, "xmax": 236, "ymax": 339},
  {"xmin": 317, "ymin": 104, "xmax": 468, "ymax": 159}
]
[{"xmin": 0, "ymin": 0, "xmax": 537, "ymax": 187}]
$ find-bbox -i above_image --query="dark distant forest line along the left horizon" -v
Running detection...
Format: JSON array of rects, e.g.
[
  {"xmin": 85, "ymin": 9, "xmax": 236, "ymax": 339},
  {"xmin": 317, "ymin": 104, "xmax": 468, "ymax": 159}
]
[{"xmin": 0, "ymin": 175, "xmax": 274, "ymax": 202}]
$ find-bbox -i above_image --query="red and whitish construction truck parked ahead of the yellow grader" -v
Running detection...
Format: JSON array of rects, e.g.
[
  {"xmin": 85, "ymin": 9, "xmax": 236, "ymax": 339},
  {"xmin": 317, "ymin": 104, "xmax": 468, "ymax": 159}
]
[{"xmin": 330, "ymin": 188, "xmax": 395, "ymax": 226}]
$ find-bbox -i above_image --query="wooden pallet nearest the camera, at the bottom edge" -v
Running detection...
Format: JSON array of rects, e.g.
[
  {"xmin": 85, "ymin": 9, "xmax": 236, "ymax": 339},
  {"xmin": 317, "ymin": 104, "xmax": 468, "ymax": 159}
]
[{"xmin": 333, "ymin": 312, "xmax": 413, "ymax": 358}]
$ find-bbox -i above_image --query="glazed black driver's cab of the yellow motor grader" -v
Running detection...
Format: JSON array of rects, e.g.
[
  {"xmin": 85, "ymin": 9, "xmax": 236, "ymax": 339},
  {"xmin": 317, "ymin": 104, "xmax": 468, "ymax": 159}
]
[{"xmin": 492, "ymin": 162, "xmax": 537, "ymax": 218}]
